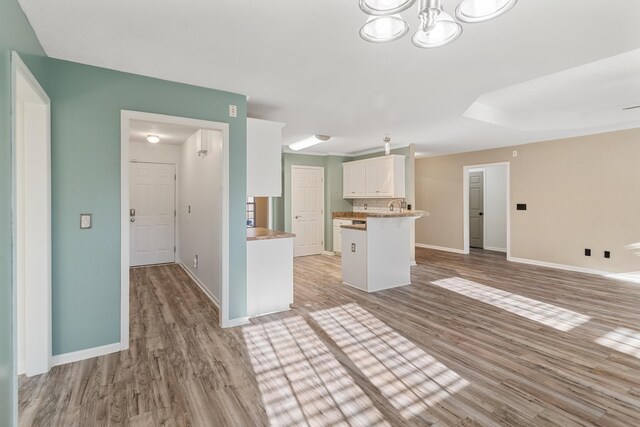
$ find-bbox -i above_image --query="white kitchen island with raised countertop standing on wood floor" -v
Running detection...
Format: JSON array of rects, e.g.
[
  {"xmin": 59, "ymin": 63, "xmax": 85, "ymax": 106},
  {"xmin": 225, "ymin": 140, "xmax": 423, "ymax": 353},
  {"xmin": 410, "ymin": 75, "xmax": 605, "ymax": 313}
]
[{"xmin": 342, "ymin": 211, "xmax": 423, "ymax": 292}]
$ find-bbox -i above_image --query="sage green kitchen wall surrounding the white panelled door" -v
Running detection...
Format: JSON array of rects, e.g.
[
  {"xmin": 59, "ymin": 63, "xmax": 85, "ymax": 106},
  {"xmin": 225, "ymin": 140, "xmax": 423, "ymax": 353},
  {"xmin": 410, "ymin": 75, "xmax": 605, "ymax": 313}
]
[{"xmin": 273, "ymin": 153, "xmax": 353, "ymax": 251}]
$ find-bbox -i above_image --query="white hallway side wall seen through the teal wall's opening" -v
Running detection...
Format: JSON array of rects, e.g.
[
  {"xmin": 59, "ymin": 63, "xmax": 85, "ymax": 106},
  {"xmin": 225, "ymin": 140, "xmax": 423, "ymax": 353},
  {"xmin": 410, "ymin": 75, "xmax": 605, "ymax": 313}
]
[{"xmin": 178, "ymin": 130, "xmax": 222, "ymax": 302}]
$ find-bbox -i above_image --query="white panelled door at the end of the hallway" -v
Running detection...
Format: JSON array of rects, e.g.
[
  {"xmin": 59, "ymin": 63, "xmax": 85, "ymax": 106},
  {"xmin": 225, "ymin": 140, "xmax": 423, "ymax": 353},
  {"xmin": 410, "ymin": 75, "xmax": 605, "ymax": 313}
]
[{"xmin": 129, "ymin": 162, "xmax": 176, "ymax": 266}]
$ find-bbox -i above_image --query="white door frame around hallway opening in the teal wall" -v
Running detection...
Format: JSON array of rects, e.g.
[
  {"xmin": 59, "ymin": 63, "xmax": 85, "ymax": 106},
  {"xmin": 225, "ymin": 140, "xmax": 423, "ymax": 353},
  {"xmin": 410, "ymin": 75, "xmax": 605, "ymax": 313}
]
[{"xmin": 120, "ymin": 110, "xmax": 231, "ymax": 350}]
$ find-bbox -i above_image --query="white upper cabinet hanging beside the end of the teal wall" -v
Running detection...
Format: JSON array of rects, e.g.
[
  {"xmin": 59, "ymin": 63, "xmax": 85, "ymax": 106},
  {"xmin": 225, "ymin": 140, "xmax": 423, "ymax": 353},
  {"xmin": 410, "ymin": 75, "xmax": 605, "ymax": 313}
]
[{"xmin": 247, "ymin": 119, "xmax": 284, "ymax": 197}]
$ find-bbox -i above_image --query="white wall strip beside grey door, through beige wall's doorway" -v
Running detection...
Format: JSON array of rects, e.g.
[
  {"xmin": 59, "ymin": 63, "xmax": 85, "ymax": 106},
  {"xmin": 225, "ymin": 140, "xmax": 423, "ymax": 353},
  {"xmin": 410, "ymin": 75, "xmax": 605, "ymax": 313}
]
[{"xmin": 484, "ymin": 166, "xmax": 507, "ymax": 252}]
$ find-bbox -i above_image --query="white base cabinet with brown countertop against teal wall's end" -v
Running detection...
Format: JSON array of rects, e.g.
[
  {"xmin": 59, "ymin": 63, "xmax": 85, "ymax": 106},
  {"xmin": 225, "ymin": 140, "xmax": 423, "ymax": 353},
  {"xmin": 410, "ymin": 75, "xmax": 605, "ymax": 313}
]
[{"xmin": 247, "ymin": 227, "xmax": 295, "ymax": 317}]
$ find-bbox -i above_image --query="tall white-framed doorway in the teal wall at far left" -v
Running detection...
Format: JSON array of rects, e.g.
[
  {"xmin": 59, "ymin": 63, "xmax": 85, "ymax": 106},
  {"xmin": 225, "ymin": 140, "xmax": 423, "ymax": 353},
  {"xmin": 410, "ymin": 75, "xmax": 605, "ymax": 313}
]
[{"xmin": 11, "ymin": 52, "xmax": 52, "ymax": 381}]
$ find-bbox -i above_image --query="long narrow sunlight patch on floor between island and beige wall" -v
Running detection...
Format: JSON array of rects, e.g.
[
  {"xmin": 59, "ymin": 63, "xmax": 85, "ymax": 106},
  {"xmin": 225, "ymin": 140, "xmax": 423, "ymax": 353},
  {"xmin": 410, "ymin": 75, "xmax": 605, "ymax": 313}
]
[{"xmin": 431, "ymin": 277, "xmax": 591, "ymax": 332}]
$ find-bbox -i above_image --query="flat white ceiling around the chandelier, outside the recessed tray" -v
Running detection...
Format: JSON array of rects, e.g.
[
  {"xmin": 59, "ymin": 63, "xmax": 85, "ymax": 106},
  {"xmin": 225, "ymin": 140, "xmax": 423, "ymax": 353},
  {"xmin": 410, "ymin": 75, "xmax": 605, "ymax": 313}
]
[{"xmin": 20, "ymin": 0, "xmax": 640, "ymax": 155}]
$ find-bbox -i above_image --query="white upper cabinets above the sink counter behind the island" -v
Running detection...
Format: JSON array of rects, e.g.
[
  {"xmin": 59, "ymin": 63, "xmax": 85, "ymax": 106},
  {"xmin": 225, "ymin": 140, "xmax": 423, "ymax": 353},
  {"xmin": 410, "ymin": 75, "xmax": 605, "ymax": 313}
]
[{"xmin": 342, "ymin": 155, "xmax": 405, "ymax": 199}]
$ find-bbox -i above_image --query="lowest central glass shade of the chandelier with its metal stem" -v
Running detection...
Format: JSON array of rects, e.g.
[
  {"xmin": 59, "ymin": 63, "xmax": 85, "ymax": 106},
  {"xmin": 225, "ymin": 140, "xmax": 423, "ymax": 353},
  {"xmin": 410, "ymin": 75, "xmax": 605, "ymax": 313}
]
[{"xmin": 411, "ymin": 0, "xmax": 462, "ymax": 48}]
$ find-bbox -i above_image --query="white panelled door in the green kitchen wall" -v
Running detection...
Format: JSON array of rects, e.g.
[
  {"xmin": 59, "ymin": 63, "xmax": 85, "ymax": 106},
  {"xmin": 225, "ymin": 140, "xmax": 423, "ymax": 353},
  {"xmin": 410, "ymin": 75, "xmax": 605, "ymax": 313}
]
[{"xmin": 291, "ymin": 166, "xmax": 324, "ymax": 256}]
